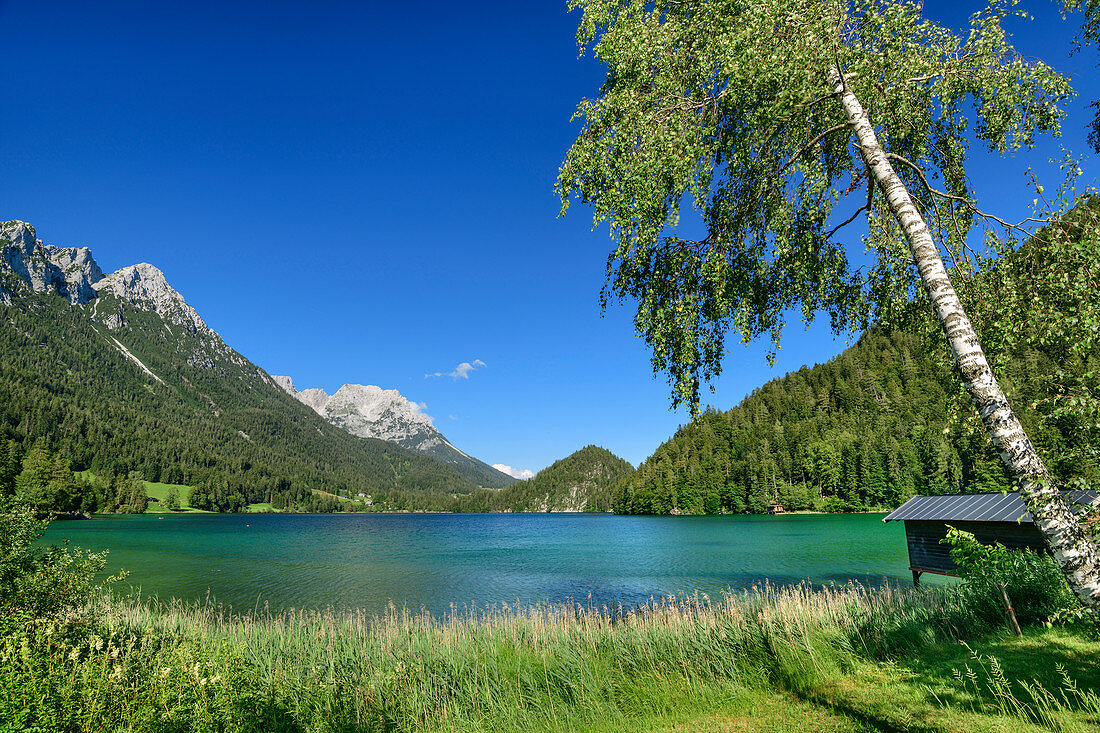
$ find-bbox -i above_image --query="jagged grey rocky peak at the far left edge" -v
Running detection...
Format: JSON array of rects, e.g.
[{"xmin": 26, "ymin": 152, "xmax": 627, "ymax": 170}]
[{"xmin": 0, "ymin": 220, "xmax": 103, "ymax": 304}]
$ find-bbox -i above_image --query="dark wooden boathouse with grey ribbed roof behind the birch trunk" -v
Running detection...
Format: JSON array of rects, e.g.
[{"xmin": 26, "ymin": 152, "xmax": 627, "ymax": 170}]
[{"xmin": 882, "ymin": 491, "xmax": 1100, "ymax": 586}]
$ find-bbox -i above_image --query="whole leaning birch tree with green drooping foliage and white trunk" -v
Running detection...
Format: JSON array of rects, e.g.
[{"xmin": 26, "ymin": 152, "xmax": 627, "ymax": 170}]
[{"xmin": 558, "ymin": 0, "xmax": 1100, "ymax": 608}]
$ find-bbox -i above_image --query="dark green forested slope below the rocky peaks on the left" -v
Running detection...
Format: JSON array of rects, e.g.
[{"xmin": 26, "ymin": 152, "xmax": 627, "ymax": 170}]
[{"xmin": 0, "ymin": 292, "xmax": 486, "ymax": 511}]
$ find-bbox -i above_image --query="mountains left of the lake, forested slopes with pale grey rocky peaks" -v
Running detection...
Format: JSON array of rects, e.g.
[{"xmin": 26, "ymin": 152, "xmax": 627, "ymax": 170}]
[{"xmin": 0, "ymin": 216, "xmax": 514, "ymax": 506}]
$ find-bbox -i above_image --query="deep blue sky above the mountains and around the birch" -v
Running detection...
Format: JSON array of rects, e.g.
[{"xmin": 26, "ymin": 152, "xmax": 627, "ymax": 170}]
[{"xmin": 0, "ymin": 0, "xmax": 1100, "ymax": 470}]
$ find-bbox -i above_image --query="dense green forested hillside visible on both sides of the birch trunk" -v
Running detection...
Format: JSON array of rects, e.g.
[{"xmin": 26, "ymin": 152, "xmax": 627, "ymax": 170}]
[{"xmin": 614, "ymin": 199, "xmax": 1100, "ymax": 514}]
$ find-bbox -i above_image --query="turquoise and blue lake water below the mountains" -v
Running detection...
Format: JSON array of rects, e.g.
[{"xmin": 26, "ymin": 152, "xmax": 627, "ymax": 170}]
[{"xmin": 38, "ymin": 514, "xmax": 924, "ymax": 614}]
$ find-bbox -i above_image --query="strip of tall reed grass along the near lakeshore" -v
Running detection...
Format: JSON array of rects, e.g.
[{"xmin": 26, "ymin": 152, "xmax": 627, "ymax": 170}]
[{"xmin": 75, "ymin": 584, "xmax": 961, "ymax": 730}]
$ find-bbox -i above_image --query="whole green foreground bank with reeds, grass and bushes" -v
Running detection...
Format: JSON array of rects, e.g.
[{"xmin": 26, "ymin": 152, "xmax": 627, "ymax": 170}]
[{"xmin": 0, "ymin": 500, "xmax": 1100, "ymax": 732}]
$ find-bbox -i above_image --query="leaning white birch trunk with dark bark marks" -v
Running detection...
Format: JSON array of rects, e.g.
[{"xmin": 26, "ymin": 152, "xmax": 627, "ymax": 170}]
[{"xmin": 829, "ymin": 67, "xmax": 1100, "ymax": 609}]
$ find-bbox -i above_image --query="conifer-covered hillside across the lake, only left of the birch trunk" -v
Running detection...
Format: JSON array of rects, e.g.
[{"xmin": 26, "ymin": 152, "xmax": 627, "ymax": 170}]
[{"xmin": 615, "ymin": 330, "xmax": 972, "ymax": 514}]
